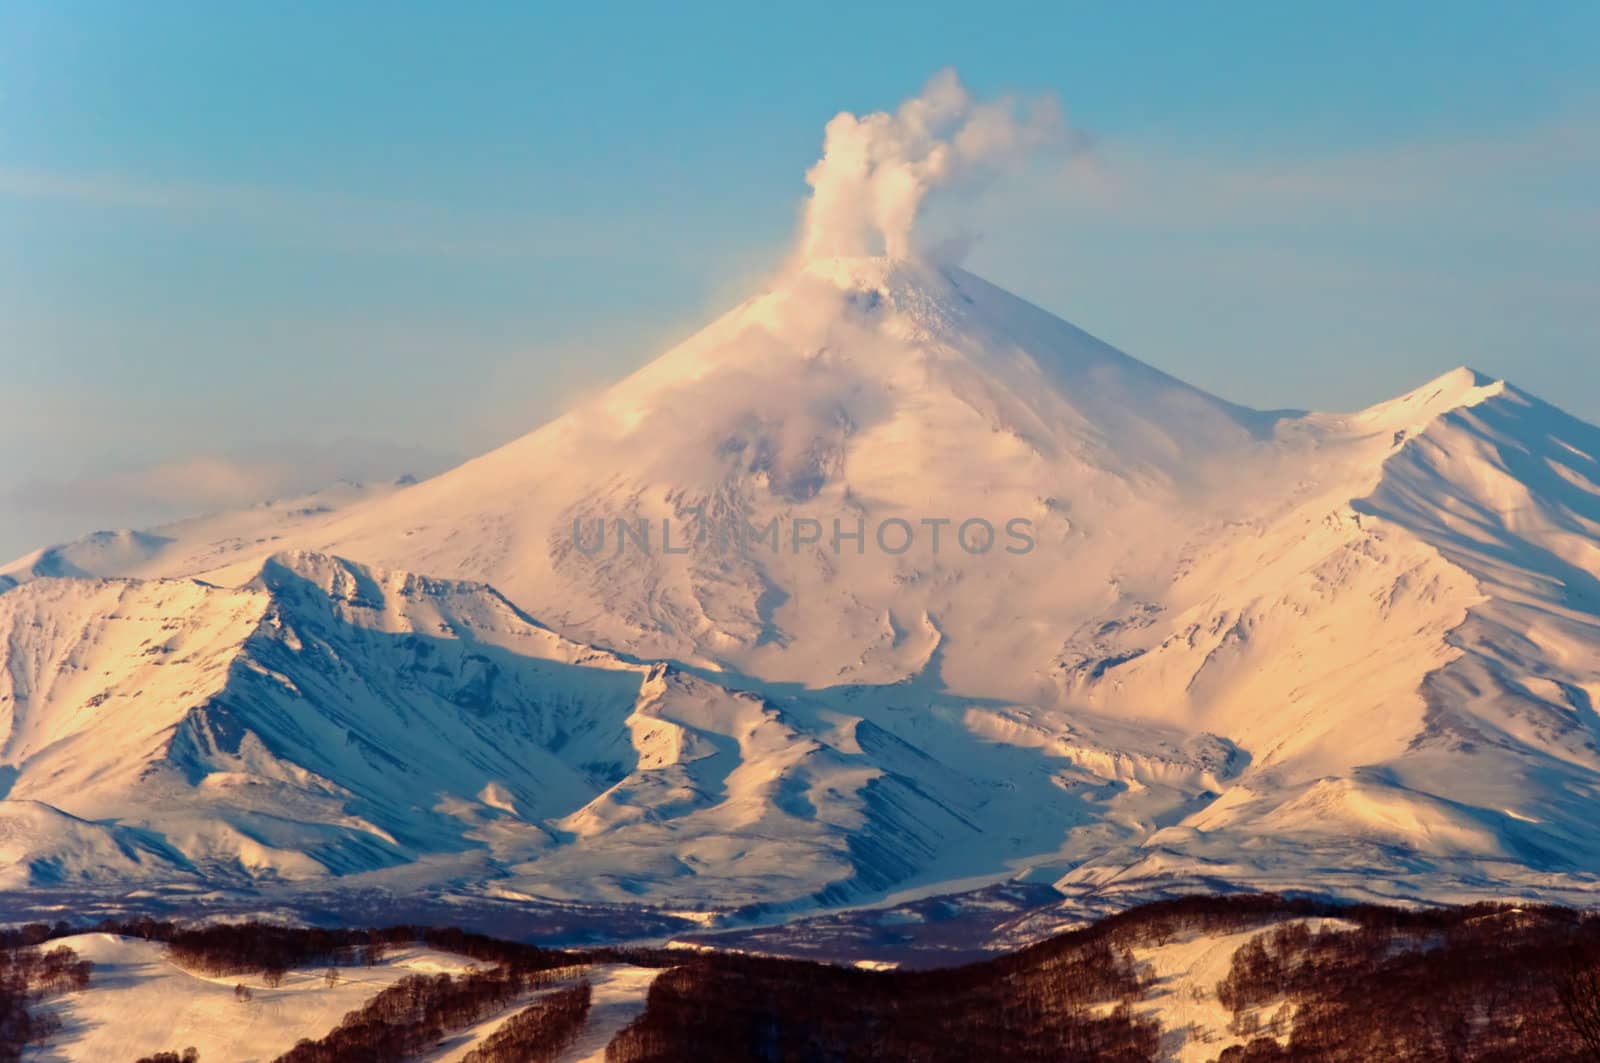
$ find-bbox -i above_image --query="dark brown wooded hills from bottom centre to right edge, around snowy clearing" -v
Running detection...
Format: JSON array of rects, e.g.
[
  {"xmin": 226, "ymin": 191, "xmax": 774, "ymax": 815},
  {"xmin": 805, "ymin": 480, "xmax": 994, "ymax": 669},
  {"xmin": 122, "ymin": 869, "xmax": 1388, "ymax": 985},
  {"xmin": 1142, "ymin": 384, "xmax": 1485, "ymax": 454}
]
[{"xmin": 608, "ymin": 895, "xmax": 1600, "ymax": 1063}]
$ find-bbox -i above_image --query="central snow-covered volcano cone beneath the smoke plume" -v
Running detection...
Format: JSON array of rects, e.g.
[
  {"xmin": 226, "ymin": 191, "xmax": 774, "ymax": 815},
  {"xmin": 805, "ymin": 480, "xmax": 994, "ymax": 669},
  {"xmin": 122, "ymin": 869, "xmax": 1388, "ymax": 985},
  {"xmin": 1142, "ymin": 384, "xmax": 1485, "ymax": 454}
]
[{"xmin": 219, "ymin": 258, "xmax": 1278, "ymax": 700}]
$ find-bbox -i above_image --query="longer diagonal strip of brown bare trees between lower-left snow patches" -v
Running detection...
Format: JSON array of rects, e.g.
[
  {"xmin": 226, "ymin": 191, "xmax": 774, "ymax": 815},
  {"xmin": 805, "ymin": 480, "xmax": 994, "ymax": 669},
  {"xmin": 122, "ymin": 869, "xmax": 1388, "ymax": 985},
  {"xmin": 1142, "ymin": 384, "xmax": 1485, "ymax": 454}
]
[{"xmin": 277, "ymin": 965, "xmax": 587, "ymax": 1063}]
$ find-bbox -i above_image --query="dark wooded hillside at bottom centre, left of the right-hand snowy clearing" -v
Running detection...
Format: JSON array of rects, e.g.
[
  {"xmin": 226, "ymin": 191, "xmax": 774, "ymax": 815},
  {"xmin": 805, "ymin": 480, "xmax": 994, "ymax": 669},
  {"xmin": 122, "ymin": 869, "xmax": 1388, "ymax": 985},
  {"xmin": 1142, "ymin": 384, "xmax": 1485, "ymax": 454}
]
[{"xmin": 606, "ymin": 940, "xmax": 1160, "ymax": 1063}]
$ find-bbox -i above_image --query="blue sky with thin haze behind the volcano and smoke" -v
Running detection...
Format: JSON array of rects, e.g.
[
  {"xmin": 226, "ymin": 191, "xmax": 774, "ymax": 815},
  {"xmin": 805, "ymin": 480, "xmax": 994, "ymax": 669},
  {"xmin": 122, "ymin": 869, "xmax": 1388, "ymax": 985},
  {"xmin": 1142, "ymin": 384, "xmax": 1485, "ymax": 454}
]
[{"xmin": 0, "ymin": 0, "xmax": 1600, "ymax": 556}]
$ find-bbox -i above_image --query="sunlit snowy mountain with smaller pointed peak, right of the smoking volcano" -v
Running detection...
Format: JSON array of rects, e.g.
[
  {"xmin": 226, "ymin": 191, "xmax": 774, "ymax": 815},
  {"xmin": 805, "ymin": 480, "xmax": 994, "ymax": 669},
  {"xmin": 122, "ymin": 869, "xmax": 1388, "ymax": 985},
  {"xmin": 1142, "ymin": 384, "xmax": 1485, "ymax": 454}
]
[{"xmin": 1043, "ymin": 370, "xmax": 1600, "ymax": 897}]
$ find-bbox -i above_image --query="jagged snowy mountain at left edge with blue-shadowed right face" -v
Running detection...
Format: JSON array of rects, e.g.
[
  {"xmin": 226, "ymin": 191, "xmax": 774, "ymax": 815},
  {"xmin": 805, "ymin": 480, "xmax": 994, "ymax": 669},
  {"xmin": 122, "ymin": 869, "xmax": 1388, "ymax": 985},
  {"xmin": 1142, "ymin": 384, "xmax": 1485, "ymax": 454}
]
[{"xmin": 0, "ymin": 556, "xmax": 638, "ymax": 882}]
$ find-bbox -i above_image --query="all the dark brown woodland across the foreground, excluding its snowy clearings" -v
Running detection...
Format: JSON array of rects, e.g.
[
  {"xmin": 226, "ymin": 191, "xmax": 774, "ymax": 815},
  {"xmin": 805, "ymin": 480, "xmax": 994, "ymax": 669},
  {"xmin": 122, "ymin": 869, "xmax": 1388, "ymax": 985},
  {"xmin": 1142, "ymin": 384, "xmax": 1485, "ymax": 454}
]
[{"xmin": 15, "ymin": 895, "xmax": 1600, "ymax": 1063}]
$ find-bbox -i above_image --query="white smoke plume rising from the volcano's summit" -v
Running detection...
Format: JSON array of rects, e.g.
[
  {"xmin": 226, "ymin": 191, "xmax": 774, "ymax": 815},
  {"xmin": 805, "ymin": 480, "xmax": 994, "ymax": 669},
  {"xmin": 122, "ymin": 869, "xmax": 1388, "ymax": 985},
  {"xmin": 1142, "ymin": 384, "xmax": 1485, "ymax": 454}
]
[{"xmin": 800, "ymin": 69, "xmax": 1064, "ymax": 259}]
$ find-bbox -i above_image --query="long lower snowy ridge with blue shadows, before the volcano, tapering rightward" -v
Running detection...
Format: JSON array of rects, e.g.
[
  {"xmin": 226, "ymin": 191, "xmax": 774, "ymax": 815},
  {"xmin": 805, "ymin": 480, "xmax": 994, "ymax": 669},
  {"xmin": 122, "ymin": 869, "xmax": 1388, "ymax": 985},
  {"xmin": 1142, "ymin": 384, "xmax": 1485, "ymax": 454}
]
[{"xmin": 0, "ymin": 554, "xmax": 1230, "ymax": 909}]
